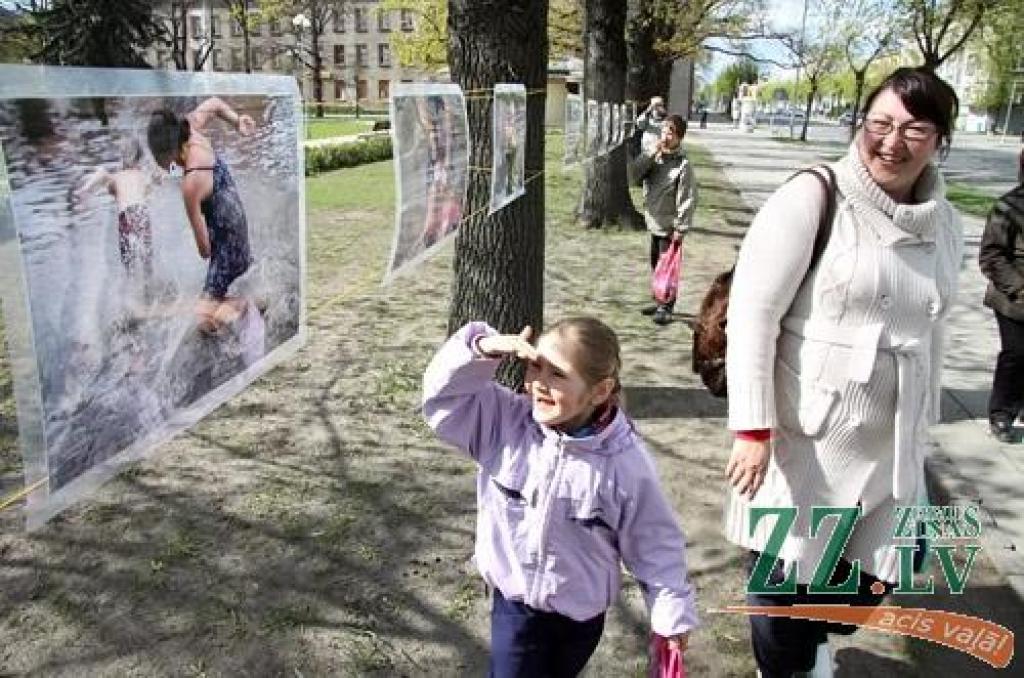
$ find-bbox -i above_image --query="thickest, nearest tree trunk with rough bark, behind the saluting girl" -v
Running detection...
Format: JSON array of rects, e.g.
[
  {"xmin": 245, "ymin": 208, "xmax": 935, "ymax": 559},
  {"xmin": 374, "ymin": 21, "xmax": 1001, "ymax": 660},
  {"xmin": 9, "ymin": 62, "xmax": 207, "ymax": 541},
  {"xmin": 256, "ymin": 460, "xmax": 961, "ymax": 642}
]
[{"xmin": 447, "ymin": 0, "xmax": 548, "ymax": 376}]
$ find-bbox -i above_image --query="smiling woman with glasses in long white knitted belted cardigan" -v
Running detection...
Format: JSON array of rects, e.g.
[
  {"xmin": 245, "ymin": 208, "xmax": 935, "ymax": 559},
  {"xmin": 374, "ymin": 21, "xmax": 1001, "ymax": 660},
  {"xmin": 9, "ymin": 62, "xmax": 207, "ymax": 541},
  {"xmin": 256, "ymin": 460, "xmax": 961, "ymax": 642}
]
[{"xmin": 726, "ymin": 69, "xmax": 964, "ymax": 676}]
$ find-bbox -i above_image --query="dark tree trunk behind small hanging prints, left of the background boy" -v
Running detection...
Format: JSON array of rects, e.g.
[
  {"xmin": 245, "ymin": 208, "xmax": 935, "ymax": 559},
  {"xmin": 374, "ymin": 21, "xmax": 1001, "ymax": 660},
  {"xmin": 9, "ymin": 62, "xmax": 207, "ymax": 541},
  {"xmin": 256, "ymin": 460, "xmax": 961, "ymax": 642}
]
[{"xmin": 579, "ymin": 0, "xmax": 642, "ymax": 228}]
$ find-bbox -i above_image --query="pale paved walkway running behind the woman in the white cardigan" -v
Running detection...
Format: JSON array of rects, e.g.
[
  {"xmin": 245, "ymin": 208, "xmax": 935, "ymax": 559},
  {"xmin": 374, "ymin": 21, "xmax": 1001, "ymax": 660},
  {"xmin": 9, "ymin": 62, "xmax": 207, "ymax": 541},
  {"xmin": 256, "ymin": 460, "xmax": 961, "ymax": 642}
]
[{"xmin": 689, "ymin": 125, "xmax": 1024, "ymax": 610}]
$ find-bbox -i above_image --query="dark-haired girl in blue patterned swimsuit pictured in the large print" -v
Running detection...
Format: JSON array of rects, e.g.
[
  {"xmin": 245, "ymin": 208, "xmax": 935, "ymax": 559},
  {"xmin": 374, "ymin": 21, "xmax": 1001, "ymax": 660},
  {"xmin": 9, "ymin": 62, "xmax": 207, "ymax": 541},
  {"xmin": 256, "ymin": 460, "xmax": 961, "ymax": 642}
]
[{"xmin": 146, "ymin": 96, "xmax": 258, "ymax": 334}]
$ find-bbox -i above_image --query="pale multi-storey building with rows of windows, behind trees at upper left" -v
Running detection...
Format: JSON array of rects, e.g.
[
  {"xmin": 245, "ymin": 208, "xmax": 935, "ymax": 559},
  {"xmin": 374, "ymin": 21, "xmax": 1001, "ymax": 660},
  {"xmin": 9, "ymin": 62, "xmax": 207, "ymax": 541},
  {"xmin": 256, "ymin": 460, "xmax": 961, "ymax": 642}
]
[{"xmin": 148, "ymin": 0, "xmax": 424, "ymax": 105}]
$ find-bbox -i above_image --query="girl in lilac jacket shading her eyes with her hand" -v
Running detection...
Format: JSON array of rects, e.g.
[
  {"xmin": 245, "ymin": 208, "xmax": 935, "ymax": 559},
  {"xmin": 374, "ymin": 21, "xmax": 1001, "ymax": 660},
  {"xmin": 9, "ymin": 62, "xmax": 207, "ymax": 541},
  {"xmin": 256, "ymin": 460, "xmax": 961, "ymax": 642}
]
[{"xmin": 423, "ymin": 317, "xmax": 697, "ymax": 677}]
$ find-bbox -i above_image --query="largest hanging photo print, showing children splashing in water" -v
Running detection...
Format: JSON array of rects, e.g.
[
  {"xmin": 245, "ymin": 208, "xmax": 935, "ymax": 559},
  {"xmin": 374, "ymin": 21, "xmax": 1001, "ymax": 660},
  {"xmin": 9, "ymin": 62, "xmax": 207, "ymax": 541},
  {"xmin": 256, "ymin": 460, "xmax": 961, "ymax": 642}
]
[{"xmin": 0, "ymin": 67, "xmax": 304, "ymax": 527}]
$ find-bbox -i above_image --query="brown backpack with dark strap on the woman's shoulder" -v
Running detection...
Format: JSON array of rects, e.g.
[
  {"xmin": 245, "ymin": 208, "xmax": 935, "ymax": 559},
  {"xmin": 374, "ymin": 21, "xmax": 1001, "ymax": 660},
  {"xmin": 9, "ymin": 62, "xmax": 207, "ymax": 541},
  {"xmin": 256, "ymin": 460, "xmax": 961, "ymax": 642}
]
[{"xmin": 693, "ymin": 165, "xmax": 836, "ymax": 397}]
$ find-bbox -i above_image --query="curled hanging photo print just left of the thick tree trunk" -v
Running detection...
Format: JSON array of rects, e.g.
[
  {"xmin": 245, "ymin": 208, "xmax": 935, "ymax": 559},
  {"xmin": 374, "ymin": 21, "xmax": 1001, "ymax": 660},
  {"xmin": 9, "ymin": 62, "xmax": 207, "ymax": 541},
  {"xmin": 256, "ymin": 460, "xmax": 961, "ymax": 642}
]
[{"xmin": 384, "ymin": 83, "xmax": 469, "ymax": 283}]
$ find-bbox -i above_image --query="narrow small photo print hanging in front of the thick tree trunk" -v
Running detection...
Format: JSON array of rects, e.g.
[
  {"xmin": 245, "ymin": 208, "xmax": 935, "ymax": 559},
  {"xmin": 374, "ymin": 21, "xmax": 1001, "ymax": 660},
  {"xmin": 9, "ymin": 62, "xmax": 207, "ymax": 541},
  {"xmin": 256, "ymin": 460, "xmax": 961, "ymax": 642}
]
[{"xmin": 488, "ymin": 83, "xmax": 526, "ymax": 214}]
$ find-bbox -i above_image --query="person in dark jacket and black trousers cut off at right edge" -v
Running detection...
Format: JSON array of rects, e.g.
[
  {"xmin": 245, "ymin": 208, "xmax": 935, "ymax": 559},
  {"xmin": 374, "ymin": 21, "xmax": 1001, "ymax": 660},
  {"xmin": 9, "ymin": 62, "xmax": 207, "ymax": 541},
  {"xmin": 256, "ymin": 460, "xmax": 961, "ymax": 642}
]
[{"xmin": 978, "ymin": 178, "xmax": 1024, "ymax": 442}]
